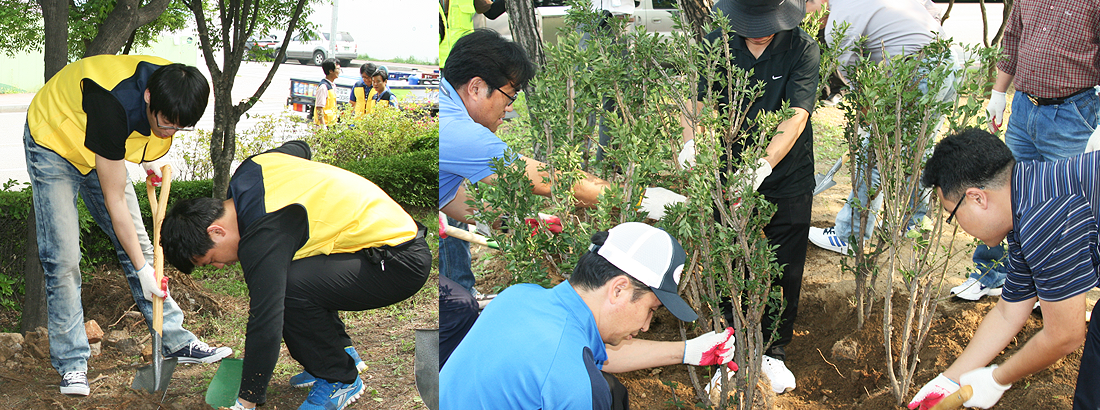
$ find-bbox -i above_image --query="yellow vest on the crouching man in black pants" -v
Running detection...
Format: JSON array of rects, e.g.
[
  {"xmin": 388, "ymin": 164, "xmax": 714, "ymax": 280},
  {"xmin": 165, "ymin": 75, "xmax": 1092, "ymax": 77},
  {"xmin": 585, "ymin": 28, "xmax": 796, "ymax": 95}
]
[{"xmin": 252, "ymin": 153, "xmax": 417, "ymax": 261}]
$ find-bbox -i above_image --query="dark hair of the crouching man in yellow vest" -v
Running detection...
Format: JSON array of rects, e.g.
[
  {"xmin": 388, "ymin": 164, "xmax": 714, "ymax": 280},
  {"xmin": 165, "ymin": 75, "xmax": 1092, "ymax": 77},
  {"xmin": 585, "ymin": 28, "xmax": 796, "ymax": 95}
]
[{"xmin": 161, "ymin": 198, "xmax": 226, "ymax": 274}]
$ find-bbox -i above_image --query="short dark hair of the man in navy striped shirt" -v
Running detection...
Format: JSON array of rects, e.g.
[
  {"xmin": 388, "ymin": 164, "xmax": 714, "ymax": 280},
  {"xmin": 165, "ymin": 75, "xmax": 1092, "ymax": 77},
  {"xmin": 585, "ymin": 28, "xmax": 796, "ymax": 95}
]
[{"xmin": 921, "ymin": 129, "xmax": 1016, "ymax": 198}]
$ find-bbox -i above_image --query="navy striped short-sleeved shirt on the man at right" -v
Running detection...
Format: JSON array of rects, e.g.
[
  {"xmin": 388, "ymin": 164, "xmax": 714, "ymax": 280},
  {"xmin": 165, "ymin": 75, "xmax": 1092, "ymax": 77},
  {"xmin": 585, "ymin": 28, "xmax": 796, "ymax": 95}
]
[{"xmin": 1001, "ymin": 152, "xmax": 1100, "ymax": 302}]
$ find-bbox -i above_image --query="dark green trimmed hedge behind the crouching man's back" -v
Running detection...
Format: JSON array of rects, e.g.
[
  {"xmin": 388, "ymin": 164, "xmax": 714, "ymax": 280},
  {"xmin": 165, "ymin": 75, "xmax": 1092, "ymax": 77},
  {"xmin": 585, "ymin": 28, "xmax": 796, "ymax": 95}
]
[{"xmin": 342, "ymin": 149, "xmax": 439, "ymax": 207}]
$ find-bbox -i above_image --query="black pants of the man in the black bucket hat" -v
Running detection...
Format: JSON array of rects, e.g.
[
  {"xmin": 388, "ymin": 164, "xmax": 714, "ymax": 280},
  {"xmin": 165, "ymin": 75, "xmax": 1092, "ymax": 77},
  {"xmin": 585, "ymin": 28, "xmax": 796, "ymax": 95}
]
[{"xmin": 722, "ymin": 193, "xmax": 814, "ymax": 361}]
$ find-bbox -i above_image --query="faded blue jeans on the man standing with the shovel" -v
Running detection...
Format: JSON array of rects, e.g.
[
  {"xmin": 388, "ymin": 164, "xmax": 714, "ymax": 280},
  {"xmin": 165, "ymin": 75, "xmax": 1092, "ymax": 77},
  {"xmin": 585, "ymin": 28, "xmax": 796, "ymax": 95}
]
[{"xmin": 23, "ymin": 121, "xmax": 195, "ymax": 375}]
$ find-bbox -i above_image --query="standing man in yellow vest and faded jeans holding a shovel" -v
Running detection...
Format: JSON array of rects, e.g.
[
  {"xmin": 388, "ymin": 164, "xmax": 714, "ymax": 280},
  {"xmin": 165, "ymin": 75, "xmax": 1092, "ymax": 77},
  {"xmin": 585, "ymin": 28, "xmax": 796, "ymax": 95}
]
[{"xmin": 23, "ymin": 55, "xmax": 233, "ymax": 396}]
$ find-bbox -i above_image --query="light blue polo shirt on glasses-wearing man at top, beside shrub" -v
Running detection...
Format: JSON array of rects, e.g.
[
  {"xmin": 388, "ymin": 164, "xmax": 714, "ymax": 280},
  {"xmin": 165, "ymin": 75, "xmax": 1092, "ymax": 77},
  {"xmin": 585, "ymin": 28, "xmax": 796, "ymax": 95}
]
[{"xmin": 439, "ymin": 78, "xmax": 514, "ymax": 208}]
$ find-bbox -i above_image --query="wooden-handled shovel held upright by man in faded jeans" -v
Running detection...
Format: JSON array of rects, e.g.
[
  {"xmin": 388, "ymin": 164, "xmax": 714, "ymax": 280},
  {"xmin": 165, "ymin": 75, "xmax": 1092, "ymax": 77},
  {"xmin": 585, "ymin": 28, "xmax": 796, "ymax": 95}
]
[{"xmin": 130, "ymin": 165, "xmax": 176, "ymax": 392}]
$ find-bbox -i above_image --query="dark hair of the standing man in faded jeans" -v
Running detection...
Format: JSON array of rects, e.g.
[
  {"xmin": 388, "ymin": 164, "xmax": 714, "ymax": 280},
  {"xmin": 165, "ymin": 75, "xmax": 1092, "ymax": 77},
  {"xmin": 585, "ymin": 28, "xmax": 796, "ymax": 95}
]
[{"xmin": 145, "ymin": 63, "xmax": 210, "ymax": 128}]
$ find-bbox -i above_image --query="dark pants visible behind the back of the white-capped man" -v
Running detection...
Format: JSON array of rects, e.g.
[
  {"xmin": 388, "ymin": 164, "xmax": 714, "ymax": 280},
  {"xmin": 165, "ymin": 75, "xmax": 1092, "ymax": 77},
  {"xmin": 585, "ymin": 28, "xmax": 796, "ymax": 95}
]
[{"xmin": 439, "ymin": 272, "xmax": 477, "ymax": 368}]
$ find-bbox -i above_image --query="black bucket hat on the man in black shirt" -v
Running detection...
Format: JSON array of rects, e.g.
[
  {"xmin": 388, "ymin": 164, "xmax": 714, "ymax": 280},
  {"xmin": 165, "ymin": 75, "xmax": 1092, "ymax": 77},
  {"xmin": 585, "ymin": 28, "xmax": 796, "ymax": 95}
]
[{"xmin": 714, "ymin": 0, "xmax": 806, "ymax": 38}]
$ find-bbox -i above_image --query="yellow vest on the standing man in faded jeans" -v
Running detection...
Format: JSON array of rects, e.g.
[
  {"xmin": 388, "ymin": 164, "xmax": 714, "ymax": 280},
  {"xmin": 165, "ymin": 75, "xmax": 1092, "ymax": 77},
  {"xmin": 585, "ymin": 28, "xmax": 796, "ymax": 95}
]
[{"xmin": 26, "ymin": 55, "xmax": 172, "ymax": 175}]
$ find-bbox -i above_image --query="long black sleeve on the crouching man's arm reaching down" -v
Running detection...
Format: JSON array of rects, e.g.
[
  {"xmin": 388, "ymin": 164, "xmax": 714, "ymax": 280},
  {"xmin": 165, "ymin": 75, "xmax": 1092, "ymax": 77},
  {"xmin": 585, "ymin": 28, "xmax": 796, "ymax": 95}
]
[{"xmin": 238, "ymin": 206, "xmax": 309, "ymax": 403}]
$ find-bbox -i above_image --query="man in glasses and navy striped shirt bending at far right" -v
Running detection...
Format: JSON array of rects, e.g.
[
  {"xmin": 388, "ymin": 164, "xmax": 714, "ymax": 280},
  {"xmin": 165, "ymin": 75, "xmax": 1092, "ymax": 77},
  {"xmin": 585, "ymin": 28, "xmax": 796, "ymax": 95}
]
[{"xmin": 909, "ymin": 129, "xmax": 1100, "ymax": 409}]
